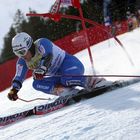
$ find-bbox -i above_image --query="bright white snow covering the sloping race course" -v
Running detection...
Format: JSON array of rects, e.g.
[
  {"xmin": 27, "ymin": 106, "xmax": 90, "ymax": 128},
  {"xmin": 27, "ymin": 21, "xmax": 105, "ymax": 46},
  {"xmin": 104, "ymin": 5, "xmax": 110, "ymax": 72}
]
[{"xmin": 0, "ymin": 28, "xmax": 140, "ymax": 140}]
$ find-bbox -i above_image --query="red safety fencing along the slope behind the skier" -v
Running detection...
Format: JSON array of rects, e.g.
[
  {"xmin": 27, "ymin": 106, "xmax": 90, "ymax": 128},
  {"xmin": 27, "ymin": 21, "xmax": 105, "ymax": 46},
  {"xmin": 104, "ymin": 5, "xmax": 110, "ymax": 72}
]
[{"xmin": 0, "ymin": 21, "xmax": 128, "ymax": 91}]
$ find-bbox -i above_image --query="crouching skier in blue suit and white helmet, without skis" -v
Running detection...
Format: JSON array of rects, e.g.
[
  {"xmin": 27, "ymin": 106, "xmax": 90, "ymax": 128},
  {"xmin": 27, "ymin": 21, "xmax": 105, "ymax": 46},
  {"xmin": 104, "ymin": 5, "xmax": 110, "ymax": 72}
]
[{"xmin": 8, "ymin": 32, "xmax": 110, "ymax": 101}]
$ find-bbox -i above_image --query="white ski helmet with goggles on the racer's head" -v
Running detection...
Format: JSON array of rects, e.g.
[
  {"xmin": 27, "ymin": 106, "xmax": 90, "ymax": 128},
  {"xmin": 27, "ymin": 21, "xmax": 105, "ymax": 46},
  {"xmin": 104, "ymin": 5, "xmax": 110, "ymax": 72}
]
[{"xmin": 12, "ymin": 32, "xmax": 33, "ymax": 57}]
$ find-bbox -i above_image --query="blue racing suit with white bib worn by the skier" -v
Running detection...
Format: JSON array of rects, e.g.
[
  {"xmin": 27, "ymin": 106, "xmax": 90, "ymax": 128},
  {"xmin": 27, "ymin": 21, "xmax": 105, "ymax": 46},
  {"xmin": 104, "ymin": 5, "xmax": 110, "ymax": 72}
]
[{"xmin": 12, "ymin": 38, "xmax": 85, "ymax": 94}]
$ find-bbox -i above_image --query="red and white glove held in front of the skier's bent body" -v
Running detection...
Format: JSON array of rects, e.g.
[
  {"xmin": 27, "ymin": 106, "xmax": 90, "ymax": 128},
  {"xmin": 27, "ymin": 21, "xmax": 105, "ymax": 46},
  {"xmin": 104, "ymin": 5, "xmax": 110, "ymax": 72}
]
[{"xmin": 33, "ymin": 66, "xmax": 47, "ymax": 80}]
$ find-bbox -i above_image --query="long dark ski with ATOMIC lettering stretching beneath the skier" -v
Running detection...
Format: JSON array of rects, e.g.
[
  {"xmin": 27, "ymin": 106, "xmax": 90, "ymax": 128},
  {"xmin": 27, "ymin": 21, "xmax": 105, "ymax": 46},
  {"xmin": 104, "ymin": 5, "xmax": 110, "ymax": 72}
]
[{"xmin": 0, "ymin": 78, "xmax": 140, "ymax": 127}]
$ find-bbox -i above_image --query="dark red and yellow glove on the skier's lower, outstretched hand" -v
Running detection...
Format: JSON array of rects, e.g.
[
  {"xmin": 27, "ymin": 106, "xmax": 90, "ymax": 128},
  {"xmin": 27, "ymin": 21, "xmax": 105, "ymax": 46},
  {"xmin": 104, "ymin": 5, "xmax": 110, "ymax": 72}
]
[{"xmin": 7, "ymin": 88, "xmax": 19, "ymax": 101}]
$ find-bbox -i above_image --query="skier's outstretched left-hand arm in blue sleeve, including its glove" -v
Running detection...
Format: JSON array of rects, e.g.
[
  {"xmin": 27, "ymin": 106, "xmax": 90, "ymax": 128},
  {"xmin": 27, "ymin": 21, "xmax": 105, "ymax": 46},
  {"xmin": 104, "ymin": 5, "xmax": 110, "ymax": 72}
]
[{"xmin": 8, "ymin": 58, "xmax": 28, "ymax": 101}]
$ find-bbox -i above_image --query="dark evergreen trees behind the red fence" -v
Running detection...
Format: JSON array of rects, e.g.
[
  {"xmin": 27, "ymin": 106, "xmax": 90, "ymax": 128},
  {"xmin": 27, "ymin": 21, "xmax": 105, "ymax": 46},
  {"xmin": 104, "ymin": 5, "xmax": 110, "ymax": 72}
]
[{"xmin": 0, "ymin": 0, "xmax": 135, "ymax": 63}]
